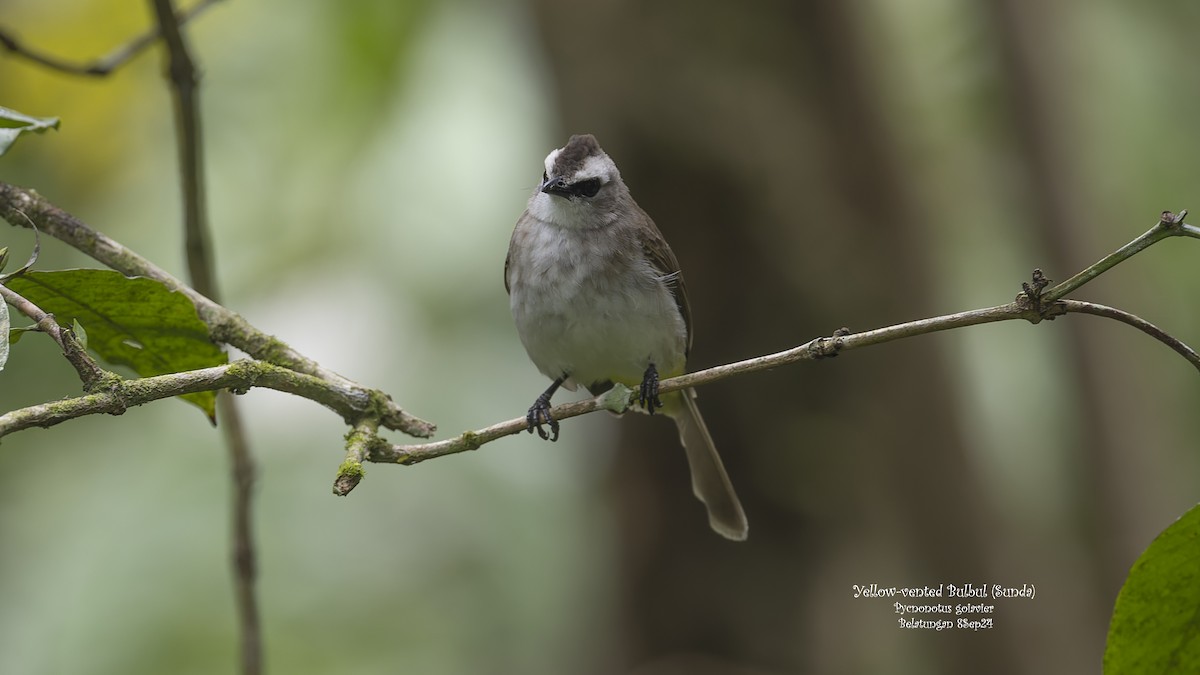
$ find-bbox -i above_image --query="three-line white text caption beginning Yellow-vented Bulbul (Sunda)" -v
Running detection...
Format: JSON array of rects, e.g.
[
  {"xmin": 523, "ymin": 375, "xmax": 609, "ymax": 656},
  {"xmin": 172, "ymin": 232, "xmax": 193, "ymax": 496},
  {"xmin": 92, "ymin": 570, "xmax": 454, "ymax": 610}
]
[{"xmin": 851, "ymin": 584, "xmax": 1038, "ymax": 631}]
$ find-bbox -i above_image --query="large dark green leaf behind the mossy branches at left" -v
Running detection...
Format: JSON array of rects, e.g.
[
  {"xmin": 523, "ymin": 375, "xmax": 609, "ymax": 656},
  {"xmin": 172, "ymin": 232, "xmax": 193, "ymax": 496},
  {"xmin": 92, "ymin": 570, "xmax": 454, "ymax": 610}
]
[{"xmin": 7, "ymin": 269, "xmax": 228, "ymax": 419}]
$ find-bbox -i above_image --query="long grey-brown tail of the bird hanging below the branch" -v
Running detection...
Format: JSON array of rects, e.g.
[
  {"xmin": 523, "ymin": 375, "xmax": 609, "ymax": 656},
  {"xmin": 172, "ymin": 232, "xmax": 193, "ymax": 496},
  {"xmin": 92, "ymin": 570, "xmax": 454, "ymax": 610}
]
[{"xmin": 664, "ymin": 389, "xmax": 750, "ymax": 542}]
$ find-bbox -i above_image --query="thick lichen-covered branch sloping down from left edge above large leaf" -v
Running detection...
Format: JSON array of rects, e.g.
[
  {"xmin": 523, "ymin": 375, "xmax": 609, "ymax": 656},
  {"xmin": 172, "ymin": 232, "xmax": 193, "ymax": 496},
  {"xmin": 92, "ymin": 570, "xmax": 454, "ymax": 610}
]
[{"xmin": 0, "ymin": 181, "xmax": 437, "ymax": 437}]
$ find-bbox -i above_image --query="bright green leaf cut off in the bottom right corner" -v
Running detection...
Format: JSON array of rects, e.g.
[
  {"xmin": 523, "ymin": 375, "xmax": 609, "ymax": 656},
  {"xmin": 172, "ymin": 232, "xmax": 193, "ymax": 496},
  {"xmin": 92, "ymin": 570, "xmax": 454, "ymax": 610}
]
[{"xmin": 1104, "ymin": 506, "xmax": 1200, "ymax": 675}]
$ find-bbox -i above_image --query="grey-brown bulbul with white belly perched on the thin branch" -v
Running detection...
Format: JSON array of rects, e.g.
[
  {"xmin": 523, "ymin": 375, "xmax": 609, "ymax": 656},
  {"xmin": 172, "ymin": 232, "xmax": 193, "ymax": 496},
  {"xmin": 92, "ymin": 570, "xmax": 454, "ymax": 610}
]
[{"xmin": 504, "ymin": 133, "xmax": 749, "ymax": 540}]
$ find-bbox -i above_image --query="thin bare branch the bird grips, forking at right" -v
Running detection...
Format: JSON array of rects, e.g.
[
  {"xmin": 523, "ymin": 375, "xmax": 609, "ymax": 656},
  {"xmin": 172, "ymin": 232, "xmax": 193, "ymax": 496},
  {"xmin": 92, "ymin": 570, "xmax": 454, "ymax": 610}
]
[{"xmin": 367, "ymin": 211, "xmax": 1200, "ymax": 465}]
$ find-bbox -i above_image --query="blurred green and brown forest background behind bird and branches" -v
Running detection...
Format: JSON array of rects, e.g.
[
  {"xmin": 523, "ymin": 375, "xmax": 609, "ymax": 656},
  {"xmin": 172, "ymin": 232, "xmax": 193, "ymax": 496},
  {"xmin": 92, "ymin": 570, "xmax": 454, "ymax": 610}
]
[{"xmin": 0, "ymin": 0, "xmax": 1200, "ymax": 674}]
